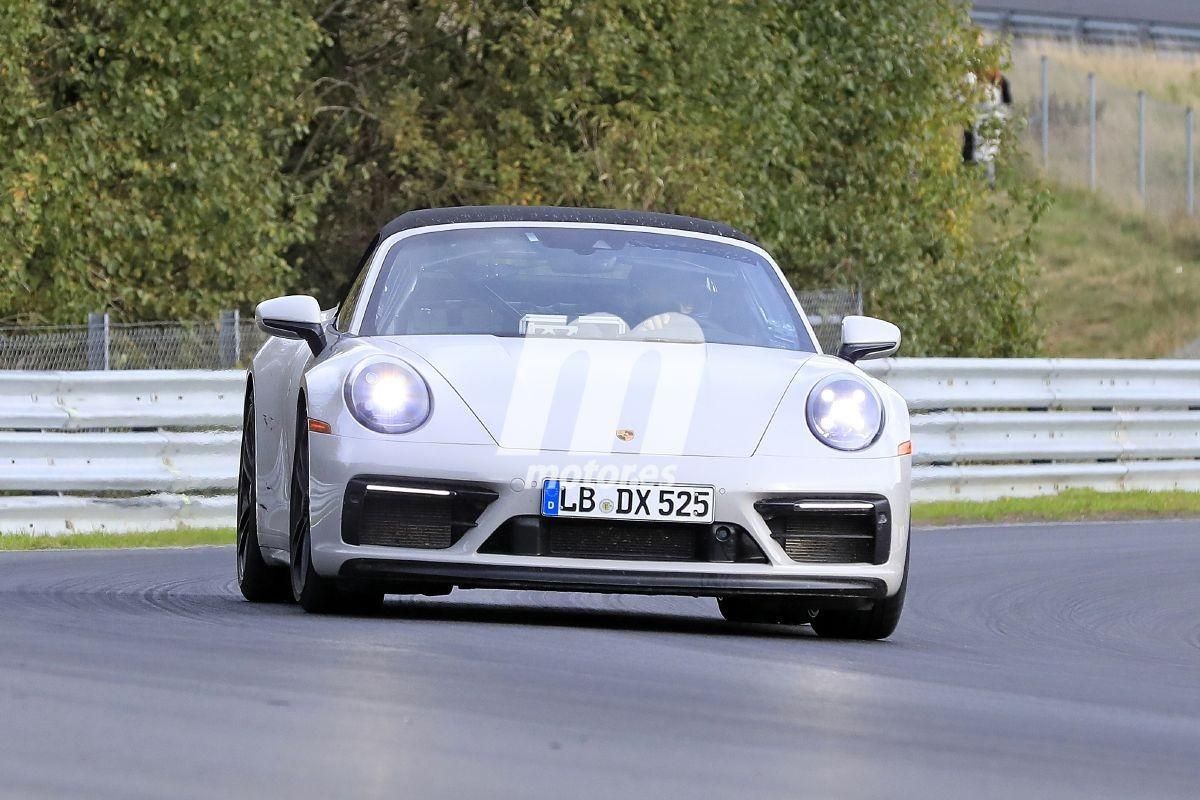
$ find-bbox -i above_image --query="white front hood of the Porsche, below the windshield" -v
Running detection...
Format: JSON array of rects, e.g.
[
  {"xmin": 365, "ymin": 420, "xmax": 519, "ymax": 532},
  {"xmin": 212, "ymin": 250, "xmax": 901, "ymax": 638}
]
[{"xmin": 377, "ymin": 336, "xmax": 812, "ymax": 457}]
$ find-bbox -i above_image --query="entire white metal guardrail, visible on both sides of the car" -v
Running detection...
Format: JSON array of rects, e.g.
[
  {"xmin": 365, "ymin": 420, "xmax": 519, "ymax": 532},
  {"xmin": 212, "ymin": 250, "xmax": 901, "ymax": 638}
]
[{"xmin": 0, "ymin": 359, "xmax": 1200, "ymax": 533}]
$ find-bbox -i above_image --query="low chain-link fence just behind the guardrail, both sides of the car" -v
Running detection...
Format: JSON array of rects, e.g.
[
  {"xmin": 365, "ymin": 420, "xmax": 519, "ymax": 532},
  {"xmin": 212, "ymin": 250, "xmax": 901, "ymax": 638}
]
[{"xmin": 0, "ymin": 289, "xmax": 863, "ymax": 369}]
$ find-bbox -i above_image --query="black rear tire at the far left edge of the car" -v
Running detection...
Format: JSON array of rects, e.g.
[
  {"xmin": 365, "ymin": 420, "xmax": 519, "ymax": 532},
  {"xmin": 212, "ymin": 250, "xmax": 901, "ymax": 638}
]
[{"xmin": 238, "ymin": 385, "xmax": 292, "ymax": 603}]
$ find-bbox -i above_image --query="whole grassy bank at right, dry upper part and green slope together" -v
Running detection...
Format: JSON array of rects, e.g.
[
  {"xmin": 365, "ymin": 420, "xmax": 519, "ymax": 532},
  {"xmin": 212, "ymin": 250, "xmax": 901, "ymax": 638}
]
[{"xmin": 1008, "ymin": 42, "xmax": 1200, "ymax": 359}]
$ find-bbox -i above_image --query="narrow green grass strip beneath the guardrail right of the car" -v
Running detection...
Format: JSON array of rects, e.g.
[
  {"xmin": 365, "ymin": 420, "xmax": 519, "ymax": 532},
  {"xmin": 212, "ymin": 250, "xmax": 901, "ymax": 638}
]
[{"xmin": 912, "ymin": 489, "xmax": 1200, "ymax": 525}]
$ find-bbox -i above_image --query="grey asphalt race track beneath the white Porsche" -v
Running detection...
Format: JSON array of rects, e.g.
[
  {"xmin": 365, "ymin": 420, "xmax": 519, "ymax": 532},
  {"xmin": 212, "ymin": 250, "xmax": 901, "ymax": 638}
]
[{"xmin": 0, "ymin": 522, "xmax": 1200, "ymax": 800}]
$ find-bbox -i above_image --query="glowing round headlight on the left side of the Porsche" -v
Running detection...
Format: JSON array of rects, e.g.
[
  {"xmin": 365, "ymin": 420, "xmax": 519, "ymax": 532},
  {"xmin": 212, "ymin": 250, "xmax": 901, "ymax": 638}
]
[{"xmin": 346, "ymin": 359, "xmax": 432, "ymax": 433}]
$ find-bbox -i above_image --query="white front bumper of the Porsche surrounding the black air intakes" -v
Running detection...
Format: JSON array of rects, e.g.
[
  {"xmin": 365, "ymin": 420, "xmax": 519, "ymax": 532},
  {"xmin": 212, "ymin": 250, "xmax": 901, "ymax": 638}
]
[{"xmin": 310, "ymin": 434, "xmax": 911, "ymax": 600}]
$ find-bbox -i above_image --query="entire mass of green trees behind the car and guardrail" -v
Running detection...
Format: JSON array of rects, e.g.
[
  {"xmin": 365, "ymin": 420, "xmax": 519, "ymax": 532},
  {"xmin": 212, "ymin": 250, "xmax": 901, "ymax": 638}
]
[{"xmin": 0, "ymin": 0, "xmax": 1043, "ymax": 355}]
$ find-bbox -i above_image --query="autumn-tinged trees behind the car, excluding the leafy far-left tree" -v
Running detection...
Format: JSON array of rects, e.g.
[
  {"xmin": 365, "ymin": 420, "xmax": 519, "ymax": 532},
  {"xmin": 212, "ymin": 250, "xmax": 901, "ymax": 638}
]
[{"xmin": 298, "ymin": 0, "xmax": 1043, "ymax": 355}]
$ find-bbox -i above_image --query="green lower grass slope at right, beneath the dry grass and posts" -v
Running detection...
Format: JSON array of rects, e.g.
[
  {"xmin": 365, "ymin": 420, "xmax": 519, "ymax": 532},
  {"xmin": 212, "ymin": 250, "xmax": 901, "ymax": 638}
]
[{"xmin": 1036, "ymin": 188, "xmax": 1200, "ymax": 359}]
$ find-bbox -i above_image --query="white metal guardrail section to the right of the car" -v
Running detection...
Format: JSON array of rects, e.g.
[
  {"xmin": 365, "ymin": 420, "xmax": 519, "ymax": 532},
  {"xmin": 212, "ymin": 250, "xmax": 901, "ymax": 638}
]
[{"xmin": 866, "ymin": 359, "xmax": 1200, "ymax": 500}]
